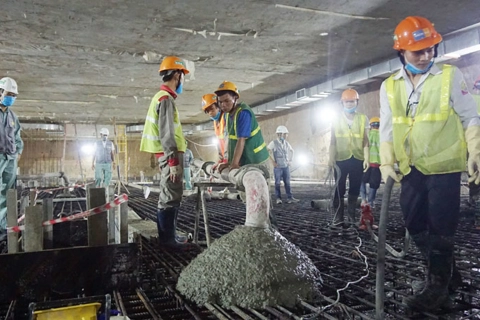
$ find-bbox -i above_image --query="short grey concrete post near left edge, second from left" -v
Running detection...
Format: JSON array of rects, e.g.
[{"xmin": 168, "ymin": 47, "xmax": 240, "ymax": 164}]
[{"xmin": 23, "ymin": 206, "xmax": 43, "ymax": 252}]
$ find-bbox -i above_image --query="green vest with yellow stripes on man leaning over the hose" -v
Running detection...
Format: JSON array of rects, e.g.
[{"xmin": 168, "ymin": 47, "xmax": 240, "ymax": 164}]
[{"xmin": 226, "ymin": 102, "xmax": 270, "ymax": 166}]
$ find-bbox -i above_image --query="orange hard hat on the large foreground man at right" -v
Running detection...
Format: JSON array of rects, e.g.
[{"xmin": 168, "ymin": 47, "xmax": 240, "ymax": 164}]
[{"xmin": 393, "ymin": 17, "xmax": 442, "ymax": 51}]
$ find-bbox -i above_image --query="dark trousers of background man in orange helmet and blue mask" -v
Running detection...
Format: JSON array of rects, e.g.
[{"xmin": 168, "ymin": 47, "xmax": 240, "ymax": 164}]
[{"xmin": 334, "ymin": 157, "xmax": 363, "ymax": 199}]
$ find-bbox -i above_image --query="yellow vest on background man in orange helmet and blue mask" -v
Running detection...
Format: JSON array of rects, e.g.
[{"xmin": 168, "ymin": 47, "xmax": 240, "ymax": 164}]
[{"xmin": 334, "ymin": 113, "xmax": 367, "ymax": 161}]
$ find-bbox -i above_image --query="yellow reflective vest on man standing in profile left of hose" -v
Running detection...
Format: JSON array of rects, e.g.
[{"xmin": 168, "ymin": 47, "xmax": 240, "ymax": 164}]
[{"xmin": 140, "ymin": 90, "xmax": 187, "ymax": 153}]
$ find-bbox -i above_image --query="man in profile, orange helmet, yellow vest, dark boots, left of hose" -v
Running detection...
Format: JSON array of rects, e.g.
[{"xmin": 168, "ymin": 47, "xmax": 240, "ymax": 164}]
[{"xmin": 140, "ymin": 56, "xmax": 189, "ymax": 246}]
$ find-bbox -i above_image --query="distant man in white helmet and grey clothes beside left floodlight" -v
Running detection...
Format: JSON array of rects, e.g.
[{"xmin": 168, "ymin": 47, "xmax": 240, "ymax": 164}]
[{"xmin": 92, "ymin": 128, "xmax": 115, "ymax": 188}]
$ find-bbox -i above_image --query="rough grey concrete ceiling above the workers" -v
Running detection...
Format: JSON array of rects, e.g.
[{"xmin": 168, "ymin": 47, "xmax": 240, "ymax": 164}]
[{"xmin": 0, "ymin": 0, "xmax": 480, "ymax": 124}]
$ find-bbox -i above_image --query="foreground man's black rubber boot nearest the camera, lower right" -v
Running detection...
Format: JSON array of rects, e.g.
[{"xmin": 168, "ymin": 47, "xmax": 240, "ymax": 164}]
[{"xmin": 403, "ymin": 235, "xmax": 453, "ymax": 311}]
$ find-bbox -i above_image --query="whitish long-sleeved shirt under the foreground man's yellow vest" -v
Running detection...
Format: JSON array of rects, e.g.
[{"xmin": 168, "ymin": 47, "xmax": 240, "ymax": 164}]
[{"xmin": 380, "ymin": 65, "xmax": 480, "ymax": 142}]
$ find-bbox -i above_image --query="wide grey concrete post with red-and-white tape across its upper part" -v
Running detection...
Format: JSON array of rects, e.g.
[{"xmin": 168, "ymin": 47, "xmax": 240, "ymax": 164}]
[{"xmin": 87, "ymin": 188, "xmax": 108, "ymax": 247}]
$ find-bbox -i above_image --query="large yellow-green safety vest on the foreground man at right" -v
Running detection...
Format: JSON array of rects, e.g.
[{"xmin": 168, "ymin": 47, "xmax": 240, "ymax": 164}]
[{"xmin": 386, "ymin": 65, "xmax": 467, "ymax": 175}]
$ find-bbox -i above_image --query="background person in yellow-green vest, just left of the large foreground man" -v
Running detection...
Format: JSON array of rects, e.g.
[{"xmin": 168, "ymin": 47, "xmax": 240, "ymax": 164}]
[{"xmin": 360, "ymin": 117, "xmax": 382, "ymax": 208}]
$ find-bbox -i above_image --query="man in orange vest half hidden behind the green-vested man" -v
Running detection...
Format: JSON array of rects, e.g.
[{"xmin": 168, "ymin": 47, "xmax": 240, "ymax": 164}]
[{"xmin": 202, "ymin": 93, "xmax": 227, "ymax": 163}]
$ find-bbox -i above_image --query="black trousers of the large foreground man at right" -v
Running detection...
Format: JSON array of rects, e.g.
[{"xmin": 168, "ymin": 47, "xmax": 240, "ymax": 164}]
[{"xmin": 400, "ymin": 167, "xmax": 461, "ymax": 237}]
